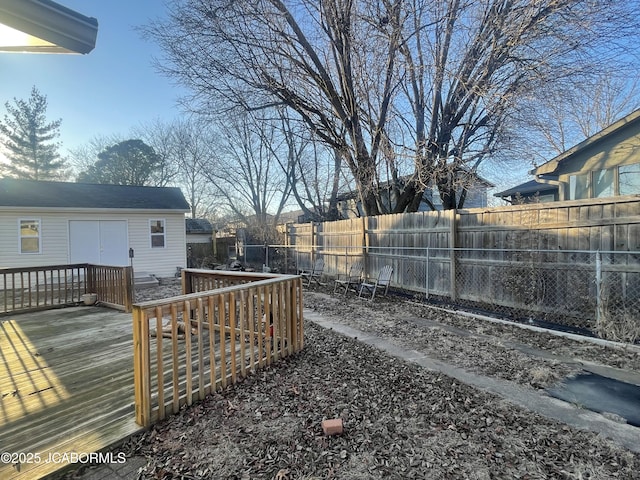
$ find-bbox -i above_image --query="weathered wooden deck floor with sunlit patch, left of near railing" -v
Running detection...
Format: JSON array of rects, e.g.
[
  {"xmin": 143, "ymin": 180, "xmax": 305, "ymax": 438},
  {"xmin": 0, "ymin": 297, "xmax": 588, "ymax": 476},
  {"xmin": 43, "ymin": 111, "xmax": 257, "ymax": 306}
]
[{"xmin": 0, "ymin": 307, "xmax": 141, "ymax": 479}]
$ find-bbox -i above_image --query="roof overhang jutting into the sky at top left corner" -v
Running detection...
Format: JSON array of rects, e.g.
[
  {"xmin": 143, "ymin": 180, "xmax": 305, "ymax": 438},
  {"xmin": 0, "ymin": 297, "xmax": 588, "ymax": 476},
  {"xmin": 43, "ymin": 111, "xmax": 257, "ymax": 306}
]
[{"xmin": 0, "ymin": 0, "xmax": 98, "ymax": 54}]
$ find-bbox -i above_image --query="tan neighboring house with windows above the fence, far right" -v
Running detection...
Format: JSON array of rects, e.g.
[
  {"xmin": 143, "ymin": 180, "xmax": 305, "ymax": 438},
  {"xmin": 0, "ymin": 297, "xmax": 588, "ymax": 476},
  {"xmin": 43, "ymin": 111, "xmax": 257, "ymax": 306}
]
[{"xmin": 530, "ymin": 110, "xmax": 640, "ymax": 200}]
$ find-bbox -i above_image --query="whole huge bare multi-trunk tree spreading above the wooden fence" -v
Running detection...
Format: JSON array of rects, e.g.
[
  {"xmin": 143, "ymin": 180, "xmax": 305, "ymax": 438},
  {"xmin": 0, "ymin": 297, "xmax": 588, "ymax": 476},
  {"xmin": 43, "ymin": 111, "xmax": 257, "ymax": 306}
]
[{"xmin": 146, "ymin": 0, "xmax": 640, "ymax": 215}]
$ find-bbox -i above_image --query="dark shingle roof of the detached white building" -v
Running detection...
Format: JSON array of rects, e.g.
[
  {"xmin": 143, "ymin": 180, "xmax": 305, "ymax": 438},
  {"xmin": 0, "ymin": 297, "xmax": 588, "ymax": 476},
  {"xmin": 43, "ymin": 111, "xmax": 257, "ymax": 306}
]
[{"xmin": 0, "ymin": 178, "xmax": 189, "ymax": 210}]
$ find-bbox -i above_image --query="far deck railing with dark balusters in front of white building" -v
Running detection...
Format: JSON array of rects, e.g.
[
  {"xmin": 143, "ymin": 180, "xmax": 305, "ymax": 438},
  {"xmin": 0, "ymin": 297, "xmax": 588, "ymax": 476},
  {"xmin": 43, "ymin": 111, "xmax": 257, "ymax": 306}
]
[{"xmin": 0, "ymin": 263, "xmax": 133, "ymax": 314}]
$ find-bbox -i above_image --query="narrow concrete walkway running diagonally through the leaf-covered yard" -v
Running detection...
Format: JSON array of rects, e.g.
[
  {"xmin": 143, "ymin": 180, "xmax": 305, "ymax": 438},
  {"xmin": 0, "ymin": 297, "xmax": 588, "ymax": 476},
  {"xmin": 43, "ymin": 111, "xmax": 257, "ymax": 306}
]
[{"xmin": 304, "ymin": 310, "xmax": 640, "ymax": 453}]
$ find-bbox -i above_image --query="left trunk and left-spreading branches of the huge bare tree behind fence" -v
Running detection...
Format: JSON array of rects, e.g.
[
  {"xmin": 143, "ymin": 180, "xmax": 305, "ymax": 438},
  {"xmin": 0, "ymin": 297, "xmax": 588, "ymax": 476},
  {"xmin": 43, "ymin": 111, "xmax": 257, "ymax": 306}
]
[{"xmin": 147, "ymin": 0, "xmax": 396, "ymax": 214}]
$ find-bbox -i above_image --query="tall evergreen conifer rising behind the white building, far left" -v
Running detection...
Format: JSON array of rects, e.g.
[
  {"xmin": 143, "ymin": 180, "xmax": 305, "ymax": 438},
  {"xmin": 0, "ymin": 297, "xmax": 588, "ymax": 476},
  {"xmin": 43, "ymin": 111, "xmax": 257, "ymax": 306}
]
[{"xmin": 0, "ymin": 87, "xmax": 65, "ymax": 180}]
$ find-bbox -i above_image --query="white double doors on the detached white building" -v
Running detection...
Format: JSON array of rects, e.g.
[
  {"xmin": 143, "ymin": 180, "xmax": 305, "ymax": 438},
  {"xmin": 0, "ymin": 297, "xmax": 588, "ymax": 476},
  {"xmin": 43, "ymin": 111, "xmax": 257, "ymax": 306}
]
[{"xmin": 69, "ymin": 220, "xmax": 129, "ymax": 266}]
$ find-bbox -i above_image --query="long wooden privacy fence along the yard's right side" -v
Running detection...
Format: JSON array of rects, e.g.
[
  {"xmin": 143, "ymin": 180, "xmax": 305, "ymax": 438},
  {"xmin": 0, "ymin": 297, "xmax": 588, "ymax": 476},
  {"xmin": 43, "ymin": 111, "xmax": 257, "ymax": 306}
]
[{"xmin": 282, "ymin": 195, "xmax": 640, "ymax": 327}]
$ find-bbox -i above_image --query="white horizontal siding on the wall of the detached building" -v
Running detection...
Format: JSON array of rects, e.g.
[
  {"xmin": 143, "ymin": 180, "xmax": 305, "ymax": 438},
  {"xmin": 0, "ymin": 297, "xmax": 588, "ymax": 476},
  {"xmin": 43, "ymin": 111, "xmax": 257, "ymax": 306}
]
[{"xmin": 0, "ymin": 207, "xmax": 187, "ymax": 277}]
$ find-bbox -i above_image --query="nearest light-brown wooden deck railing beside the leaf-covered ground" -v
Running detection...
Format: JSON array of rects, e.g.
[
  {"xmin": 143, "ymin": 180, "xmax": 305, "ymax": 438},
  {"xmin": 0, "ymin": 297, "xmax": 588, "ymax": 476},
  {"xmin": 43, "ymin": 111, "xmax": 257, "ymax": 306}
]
[{"xmin": 133, "ymin": 269, "xmax": 304, "ymax": 427}]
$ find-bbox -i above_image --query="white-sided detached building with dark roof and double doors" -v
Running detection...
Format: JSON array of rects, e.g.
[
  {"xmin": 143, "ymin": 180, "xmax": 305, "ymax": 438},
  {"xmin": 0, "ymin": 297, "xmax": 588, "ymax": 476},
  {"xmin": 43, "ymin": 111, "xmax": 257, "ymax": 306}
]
[{"xmin": 0, "ymin": 179, "xmax": 189, "ymax": 277}]
